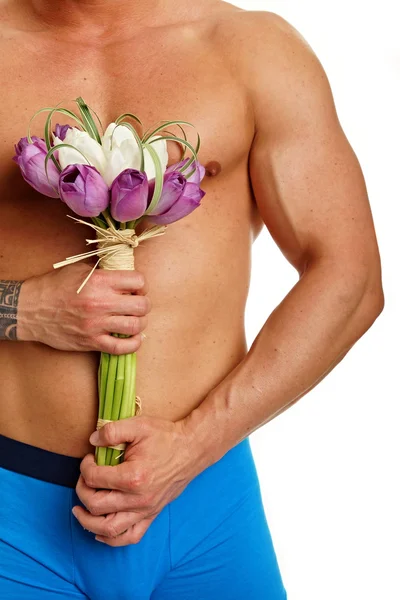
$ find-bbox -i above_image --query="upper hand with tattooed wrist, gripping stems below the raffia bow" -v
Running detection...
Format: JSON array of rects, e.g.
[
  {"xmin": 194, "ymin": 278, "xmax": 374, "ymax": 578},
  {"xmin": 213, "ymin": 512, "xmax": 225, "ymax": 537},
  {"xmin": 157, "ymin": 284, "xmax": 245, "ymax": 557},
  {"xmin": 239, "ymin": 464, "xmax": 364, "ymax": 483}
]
[{"xmin": 17, "ymin": 263, "xmax": 151, "ymax": 354}]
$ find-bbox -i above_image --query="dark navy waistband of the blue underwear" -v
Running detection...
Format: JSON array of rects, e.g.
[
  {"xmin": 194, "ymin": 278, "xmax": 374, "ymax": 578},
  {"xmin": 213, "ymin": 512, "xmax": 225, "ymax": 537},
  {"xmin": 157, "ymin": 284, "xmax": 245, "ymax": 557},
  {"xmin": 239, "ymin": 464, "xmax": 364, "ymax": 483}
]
[{"xmin": 0, "ymin": 434, "xmax": 82, "ymax": 488}]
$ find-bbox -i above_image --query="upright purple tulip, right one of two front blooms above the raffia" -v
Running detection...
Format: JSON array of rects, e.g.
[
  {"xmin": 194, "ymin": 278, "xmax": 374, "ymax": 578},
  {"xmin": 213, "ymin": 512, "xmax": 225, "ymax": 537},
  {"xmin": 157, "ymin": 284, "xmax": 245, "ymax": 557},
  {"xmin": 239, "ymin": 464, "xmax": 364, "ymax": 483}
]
[{"xmin": 111, "ymin": 169, "xmax": 149, "ymax": 223}]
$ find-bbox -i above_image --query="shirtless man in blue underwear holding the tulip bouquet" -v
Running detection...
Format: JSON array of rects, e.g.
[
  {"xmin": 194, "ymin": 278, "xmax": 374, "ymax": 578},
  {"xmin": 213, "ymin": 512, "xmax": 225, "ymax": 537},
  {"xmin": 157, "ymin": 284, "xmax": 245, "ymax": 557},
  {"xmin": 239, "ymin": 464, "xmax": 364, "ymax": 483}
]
[{"xmin": 0, "ymin": 0, "xmax": 384, "ymax": 600}]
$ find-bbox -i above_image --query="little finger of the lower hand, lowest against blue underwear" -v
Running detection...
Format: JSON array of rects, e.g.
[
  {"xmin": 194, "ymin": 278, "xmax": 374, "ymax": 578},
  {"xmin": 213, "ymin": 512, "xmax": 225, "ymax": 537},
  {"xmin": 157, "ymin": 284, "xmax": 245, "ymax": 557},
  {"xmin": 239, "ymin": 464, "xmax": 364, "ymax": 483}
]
[{"xmin": 72, "ymin": 505, "xmax": 143, "ymax": 538}]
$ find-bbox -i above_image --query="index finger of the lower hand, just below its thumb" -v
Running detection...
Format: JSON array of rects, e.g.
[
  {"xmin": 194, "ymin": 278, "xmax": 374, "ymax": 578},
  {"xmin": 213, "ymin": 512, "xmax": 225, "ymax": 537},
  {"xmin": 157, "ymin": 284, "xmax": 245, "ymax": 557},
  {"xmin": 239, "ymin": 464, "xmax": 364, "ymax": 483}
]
[{"xmin": 81, "ymin": 454, "xmax": 140, "ymax": 494}]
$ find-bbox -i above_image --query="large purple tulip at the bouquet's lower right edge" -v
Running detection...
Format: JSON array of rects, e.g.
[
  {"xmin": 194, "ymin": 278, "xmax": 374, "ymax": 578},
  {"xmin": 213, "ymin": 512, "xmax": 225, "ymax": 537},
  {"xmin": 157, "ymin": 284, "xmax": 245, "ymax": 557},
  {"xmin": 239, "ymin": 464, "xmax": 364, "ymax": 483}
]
[{"xmin": 147, "ymin": 169, "xmax": 205, "ymax": 225}]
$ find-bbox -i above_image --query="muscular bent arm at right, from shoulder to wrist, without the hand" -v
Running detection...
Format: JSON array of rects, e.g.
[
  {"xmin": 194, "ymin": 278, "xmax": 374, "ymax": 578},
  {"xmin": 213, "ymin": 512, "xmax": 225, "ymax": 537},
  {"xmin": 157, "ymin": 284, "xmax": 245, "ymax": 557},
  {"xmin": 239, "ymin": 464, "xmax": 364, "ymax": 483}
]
[{"xmin": 186, "ymin": 12, "xmax": 384, "ymax": 465}]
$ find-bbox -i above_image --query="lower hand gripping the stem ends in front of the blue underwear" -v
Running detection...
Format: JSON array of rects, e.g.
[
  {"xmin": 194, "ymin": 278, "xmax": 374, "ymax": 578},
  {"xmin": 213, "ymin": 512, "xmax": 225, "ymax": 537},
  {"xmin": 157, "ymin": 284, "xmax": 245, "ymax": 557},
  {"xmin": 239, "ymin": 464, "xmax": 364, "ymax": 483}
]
[{"xmin": 73, "ymin": 416, "xmax": 200, "ymax": 546}]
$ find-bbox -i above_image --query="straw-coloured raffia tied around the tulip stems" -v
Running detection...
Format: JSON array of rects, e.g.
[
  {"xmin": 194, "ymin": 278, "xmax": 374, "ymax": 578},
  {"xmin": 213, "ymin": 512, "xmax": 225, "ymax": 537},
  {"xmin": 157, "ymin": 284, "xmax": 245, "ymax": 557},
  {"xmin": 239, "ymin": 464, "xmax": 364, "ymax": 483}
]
[{"xmin": 53, "ymin": 215, "xmax": 167, "ymax": 452}]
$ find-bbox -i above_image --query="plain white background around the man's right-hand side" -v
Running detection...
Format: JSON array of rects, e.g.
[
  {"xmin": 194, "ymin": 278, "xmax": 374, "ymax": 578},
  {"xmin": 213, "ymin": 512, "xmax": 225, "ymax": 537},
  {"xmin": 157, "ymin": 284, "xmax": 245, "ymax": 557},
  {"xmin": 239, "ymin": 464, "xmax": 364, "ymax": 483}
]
[{"xmin": 232, "ymin": 0, "xmax": 400, "ymax": 600}]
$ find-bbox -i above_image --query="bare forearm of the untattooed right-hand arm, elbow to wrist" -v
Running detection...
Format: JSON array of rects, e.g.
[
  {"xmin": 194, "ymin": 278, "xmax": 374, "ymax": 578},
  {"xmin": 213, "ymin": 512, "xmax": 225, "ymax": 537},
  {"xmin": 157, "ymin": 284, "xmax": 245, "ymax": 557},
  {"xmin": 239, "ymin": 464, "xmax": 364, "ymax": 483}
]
[{"xmin": 185, "ymin": 261, "xmax": 383, "ymax": 466}]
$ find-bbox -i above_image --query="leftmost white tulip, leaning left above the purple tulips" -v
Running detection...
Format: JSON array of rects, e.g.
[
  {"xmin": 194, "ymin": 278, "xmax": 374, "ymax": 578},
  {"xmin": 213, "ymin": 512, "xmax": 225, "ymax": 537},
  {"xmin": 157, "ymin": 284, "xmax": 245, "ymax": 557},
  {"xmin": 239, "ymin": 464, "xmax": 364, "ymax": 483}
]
[{"xmin": 54, "ymin": 127, "xmax": 106, "ymax": 176}]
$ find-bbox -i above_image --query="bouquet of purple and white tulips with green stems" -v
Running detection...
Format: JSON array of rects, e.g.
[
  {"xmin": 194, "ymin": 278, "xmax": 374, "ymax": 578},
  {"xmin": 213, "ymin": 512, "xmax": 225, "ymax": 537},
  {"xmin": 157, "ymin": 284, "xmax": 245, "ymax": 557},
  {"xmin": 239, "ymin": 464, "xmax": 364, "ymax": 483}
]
[{"xmin": 13, "ymin": 97, "xmax": 205, "ymax": 465}]
